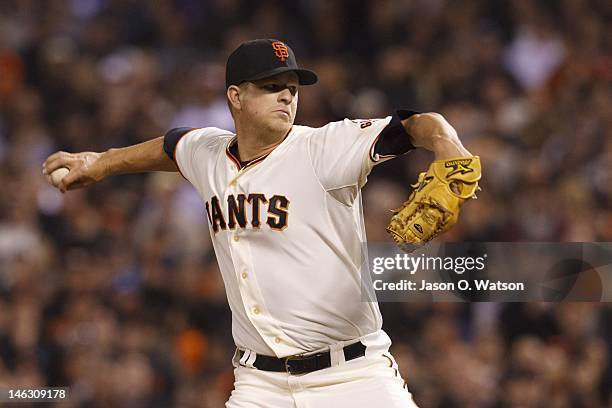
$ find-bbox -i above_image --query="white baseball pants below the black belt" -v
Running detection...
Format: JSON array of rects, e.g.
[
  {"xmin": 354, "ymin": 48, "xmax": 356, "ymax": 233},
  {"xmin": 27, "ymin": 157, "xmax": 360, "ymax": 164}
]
[{"xmin": 225, "ymin": 331, "xmax": 417, "ymax": 408}]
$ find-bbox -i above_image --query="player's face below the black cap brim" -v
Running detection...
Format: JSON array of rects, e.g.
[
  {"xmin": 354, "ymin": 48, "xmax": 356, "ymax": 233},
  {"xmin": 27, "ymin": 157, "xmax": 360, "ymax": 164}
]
[{"xmin": 242, "ymin": 72, "xmax": 299, "ymax": 132}]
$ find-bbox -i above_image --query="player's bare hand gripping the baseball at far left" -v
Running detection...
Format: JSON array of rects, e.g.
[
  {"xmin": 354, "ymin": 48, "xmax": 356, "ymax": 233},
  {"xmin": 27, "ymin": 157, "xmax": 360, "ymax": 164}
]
[{"xmin": 43, "ymin": 152, "xmax": 106, "ymax": 193}]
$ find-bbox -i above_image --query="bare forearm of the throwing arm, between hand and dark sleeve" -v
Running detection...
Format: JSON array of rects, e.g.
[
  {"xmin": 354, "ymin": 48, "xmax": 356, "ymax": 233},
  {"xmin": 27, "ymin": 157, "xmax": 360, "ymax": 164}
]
[{"xmin": 99, "ymin": 136, "xmax": 178, "ymax": 177}]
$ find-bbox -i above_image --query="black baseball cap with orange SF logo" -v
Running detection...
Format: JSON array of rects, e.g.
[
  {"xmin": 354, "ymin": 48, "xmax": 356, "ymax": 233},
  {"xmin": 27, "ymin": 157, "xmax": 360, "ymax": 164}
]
[{"xmin": 225, "ymin": 38, "xmax": 318, "ymax": 89}]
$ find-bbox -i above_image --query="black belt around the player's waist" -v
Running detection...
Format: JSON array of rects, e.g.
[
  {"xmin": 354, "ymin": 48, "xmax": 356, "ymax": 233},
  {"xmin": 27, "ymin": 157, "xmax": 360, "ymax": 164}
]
[{"xmin": 238, "ymin": 341, "xmax": 366, "ymax": 374}]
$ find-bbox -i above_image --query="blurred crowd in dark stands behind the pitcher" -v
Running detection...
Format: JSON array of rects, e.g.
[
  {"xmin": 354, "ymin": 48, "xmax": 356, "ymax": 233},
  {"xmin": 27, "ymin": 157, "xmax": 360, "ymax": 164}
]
[{"xmin": 0, "ymin": 0, "xmax": 612, "ymax": 408}]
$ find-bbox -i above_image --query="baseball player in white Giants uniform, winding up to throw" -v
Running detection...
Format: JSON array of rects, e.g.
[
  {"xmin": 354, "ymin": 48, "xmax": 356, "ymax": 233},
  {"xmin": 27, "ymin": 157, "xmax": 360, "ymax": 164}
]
[{"xmin": 43, "ymin": 39, "xmax": 480, "ymax": 408}]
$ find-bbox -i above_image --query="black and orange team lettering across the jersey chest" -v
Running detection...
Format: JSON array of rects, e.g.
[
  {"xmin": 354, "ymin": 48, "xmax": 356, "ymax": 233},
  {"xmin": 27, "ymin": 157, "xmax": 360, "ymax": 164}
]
[{"xmin": 205, "ymin": 193, "xmax": 289, "ymax": 233}]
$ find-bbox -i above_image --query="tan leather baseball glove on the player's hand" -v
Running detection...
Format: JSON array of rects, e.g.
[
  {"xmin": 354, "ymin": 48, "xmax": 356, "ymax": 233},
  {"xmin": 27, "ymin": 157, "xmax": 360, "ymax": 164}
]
[{"xmin": 387, "ymin": 156, "xmax": 481, "ymax": 252}]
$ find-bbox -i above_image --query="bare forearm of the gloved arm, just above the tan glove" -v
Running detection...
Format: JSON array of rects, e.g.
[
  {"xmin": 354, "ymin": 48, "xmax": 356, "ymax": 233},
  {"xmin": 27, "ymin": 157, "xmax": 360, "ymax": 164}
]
[{"xmin": 402, "ymin": 113, "xmax": 472, "ymax": 160}]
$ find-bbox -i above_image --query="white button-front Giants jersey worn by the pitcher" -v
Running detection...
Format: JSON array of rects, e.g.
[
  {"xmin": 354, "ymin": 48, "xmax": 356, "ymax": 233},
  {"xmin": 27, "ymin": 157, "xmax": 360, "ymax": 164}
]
[{"xmin": 174, "ymin": 116, "xmax": 402, "ymax": 357}]
